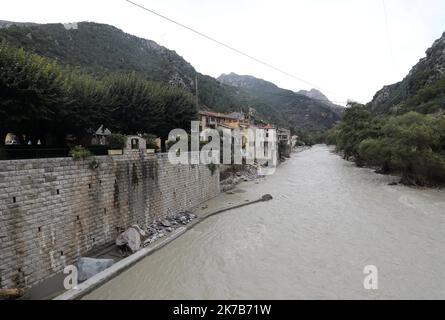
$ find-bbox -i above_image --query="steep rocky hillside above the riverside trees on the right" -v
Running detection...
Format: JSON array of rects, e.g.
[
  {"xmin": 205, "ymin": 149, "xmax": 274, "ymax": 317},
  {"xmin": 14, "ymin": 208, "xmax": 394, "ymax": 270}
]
[{"xmin": 368, "ymin": 33, "xmax": 445, "ymax": 114}]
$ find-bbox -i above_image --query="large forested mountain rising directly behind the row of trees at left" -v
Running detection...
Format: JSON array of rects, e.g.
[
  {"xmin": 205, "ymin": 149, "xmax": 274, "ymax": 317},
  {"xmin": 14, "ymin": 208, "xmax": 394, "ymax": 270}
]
[{"xmin": 0, "ymin": 22, "xmax": 241, "ymax": 110}]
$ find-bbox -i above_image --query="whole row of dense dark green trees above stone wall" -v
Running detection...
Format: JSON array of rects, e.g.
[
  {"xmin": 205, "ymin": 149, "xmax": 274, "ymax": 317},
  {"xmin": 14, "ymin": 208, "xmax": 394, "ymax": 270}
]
[{"xmin": 0, "ymin": 42, "xmax": 197, "ymax": 145}]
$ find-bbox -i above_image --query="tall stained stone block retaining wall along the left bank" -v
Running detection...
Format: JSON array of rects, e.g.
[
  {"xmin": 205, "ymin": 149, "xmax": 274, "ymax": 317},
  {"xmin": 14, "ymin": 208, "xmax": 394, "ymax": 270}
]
[{"xmin": 0, "ymin": 151, "xmax": 219, "ymax": 288}]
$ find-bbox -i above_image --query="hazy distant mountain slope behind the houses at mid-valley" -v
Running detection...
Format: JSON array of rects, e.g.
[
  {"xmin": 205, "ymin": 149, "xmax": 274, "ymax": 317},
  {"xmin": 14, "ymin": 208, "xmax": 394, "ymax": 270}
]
[{"xmin": 218, "ymin": 73, "xmax": 341, "ymax": 131}]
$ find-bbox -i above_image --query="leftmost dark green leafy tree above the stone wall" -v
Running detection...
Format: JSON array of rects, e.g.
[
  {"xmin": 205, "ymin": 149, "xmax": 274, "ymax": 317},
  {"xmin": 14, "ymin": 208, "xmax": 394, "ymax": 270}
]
[{"xmin": 0, "ymin": 42, "xmax": 66, "ymax": 144}]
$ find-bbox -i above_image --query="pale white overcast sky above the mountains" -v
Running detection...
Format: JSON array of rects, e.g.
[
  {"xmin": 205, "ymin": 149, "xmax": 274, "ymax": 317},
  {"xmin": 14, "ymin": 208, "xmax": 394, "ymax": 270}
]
[{"xmin": 0, "ymin": 0, "xmax": 445, "ymax": 102}]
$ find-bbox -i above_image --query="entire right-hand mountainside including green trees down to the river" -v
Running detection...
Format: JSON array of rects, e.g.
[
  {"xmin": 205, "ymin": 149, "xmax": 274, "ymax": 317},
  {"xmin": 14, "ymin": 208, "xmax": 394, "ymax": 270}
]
[{"xmin": 326, "ymin": 33, "xmax": 445, "ymax": 185}]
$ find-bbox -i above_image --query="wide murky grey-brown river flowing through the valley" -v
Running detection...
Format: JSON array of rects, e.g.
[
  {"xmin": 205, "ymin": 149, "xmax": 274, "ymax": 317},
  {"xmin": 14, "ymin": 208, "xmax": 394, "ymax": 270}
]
[{"xmin": 85, "ymin": 145, "xmax": 445, "ymax": 299}]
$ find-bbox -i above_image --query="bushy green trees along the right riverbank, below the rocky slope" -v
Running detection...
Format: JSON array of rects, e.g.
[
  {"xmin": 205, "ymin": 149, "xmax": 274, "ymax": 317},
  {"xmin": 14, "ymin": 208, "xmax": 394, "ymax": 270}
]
[{"xmin": 326, "ymin": 104, "xmax": 445, "ymax": 185}]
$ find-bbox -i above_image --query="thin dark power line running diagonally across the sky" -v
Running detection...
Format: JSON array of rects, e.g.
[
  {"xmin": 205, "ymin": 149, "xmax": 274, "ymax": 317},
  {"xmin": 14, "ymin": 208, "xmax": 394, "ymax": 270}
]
[{"xmin": 125, "ymin": 0, "xmax": 349, "ymax": 103}]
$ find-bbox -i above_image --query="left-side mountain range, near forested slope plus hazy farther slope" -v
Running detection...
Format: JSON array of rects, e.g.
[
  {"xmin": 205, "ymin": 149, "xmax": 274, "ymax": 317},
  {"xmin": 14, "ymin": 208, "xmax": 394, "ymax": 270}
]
[{"xmin": 0, "ymin": 21, "xmax": 339, "ymax": 131}]
